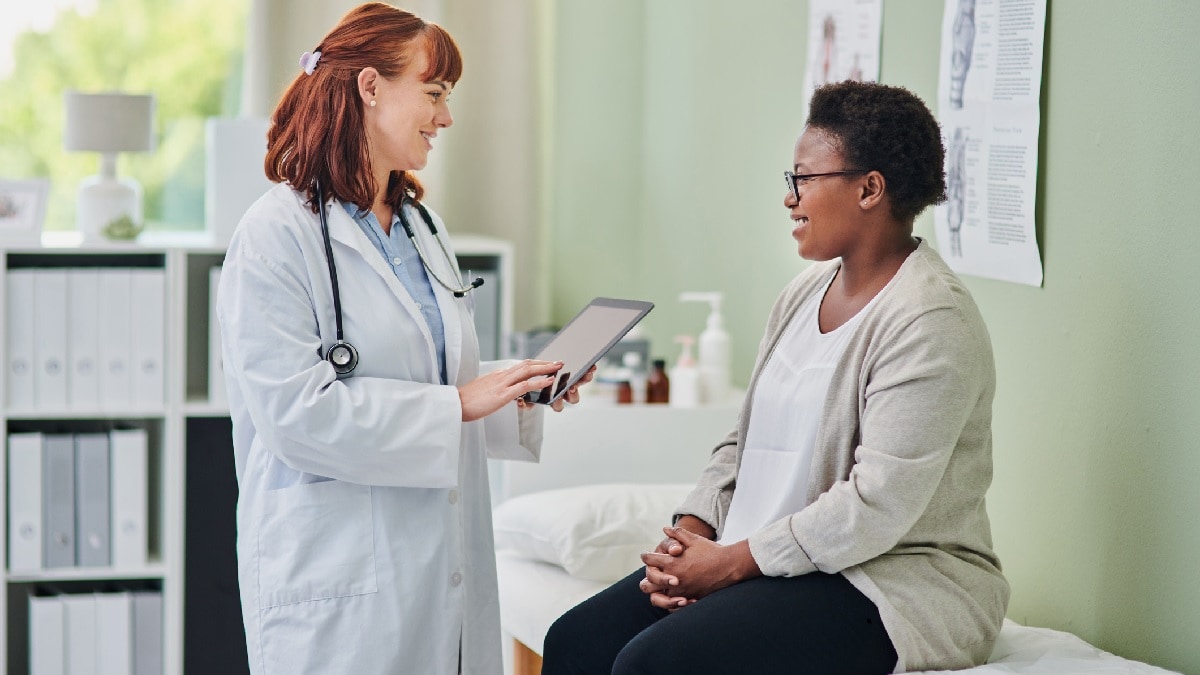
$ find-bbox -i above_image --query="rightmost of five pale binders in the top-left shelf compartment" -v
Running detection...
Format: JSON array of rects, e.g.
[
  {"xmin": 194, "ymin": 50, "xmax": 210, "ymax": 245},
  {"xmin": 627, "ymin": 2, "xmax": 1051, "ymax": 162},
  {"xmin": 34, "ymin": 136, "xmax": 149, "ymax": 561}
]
[{"xmin": 130, "ymin": 268, "xmax": 167, "ymax": 408}]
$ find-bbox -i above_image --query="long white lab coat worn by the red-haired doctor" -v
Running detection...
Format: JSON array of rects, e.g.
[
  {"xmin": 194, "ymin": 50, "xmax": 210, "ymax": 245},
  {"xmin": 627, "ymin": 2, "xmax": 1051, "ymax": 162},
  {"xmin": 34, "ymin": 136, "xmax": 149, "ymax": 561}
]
[{"xmin": 218, "ymin": 185, "xmax": 541, "ymax": 675}]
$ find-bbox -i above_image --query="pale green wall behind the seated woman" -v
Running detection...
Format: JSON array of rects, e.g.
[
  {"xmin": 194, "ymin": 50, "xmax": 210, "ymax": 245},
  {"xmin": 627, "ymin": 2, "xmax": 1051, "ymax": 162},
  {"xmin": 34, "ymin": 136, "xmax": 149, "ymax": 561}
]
[{"xmin": 541, "ymin": 0, "xmax": 1200, "ymax": 673}]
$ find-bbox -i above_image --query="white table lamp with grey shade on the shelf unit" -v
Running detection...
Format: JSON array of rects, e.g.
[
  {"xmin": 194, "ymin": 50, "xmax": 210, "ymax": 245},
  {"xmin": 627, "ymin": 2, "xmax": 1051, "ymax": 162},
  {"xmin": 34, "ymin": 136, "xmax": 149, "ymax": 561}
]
[{"xmin": 64, "ymin": 91, "xmax": 155, "ymax": 241}]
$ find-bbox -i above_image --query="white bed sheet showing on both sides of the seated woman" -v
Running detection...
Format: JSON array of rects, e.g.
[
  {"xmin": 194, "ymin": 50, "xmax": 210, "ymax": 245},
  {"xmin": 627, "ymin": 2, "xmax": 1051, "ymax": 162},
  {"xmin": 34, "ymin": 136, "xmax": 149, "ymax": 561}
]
[{"xmin": 497, "ymin": 551, "xmax": 1171, "ymax": 675}]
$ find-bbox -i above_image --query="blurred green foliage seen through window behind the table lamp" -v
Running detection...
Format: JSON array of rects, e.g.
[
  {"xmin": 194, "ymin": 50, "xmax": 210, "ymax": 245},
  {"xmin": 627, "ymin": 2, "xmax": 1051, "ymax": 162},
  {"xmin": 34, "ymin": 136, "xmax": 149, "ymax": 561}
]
[{"xmin": 0, "ymin": 0, "xmax": 248, "ymax": 229}]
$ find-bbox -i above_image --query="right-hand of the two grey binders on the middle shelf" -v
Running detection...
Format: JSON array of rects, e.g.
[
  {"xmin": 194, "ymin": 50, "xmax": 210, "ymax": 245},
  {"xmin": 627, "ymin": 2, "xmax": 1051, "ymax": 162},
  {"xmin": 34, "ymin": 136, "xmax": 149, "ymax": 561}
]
[{"xmin": 74, "ymin": 434, "xmax": 112, "ymax": 567}]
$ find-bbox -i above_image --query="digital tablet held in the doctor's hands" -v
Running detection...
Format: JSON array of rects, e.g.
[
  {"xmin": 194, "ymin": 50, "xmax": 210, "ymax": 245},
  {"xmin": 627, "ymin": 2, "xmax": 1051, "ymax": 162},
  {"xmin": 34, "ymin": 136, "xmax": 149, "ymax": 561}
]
[{"xmin": 524, "ymin": 298, "xmax": 654, "ymax": 405}]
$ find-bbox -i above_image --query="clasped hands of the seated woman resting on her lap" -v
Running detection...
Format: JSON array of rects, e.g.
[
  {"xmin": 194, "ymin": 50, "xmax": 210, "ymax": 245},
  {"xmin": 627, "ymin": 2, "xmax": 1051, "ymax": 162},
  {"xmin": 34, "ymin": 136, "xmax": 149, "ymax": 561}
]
[{"xmin": 642, "ymin": 527, "xmax": 762, "ymax": 598}]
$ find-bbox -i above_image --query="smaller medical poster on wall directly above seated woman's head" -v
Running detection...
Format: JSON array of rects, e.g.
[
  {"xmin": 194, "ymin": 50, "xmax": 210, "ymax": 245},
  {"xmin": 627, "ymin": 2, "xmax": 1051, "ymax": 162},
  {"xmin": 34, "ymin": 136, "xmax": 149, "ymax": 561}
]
[{"xmin": 804, "ymin": 0, "xmax": 883, "ymax": 101}]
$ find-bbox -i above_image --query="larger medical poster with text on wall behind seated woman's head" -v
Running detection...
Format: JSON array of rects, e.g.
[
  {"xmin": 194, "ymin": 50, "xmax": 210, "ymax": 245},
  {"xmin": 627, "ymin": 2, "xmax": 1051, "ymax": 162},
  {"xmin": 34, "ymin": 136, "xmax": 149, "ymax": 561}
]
[{"xmin": 934, "ymin": 0, "xmax": 1046, "ymax": 286}]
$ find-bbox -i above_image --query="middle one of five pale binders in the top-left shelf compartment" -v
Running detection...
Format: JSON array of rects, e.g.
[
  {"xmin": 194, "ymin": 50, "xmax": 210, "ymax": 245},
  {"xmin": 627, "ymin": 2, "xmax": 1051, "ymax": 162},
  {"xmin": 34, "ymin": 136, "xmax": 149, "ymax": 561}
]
[{"xmin": 67, "ymin": 268, "xmax": 100, "ymax": 410}]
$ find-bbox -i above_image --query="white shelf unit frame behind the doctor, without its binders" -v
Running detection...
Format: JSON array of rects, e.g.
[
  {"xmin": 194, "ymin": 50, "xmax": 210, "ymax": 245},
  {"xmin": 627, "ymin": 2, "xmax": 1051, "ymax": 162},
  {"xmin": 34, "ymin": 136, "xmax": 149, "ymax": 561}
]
[{"xmin": 0, "ymin": 233, "xmax": 512, "ymax": 675}]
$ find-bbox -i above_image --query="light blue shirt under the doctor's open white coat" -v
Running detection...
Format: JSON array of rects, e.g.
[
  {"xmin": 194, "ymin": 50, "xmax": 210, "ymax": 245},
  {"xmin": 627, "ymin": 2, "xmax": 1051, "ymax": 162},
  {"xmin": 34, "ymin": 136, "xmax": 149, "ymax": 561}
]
[{"xmin": 342, "ymin": 202, "xmax": 446, "ymax": 384}]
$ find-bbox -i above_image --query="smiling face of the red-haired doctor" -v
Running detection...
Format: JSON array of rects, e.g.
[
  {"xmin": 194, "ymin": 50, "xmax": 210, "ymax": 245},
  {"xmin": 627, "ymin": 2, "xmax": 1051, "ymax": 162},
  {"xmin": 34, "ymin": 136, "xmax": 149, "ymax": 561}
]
[{"xmin": 364, "ymin": 47, "xmax": 454, "ymax": 177}]
